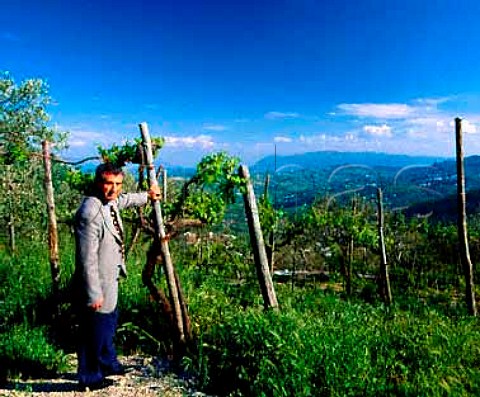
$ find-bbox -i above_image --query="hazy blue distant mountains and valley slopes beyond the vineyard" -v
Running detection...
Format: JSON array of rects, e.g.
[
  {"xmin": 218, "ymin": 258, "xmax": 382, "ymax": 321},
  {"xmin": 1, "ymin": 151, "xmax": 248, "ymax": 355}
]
[{"xmin": 246, "ymin": 151, "xmax": 480, "ymax": 221}]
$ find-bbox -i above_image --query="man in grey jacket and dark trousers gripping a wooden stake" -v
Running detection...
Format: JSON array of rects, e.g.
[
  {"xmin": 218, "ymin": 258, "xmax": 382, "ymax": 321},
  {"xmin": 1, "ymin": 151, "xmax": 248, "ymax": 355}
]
[{"xmin": 74, "ymin": 163, "xmax": 160, "ymax": 390}]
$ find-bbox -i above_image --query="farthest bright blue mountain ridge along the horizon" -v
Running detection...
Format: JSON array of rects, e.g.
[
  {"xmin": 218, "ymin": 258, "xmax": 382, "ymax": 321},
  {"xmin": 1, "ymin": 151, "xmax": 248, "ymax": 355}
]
[{"xmin": 252, "ymin": 151, "xmax": 448, "ymax": 173}]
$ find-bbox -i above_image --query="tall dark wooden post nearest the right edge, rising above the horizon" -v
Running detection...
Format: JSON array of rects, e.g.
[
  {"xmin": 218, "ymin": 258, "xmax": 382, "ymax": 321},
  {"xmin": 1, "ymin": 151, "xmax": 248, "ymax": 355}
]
[{"xmin": 455, "ymin": 117, "xmax": 477, "ymax": 316}]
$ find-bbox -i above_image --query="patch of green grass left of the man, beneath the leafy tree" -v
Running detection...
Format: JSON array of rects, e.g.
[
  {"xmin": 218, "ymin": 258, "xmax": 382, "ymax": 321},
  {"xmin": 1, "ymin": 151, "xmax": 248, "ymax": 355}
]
[{"xmin": 0, "ymin": 237, "xmax": 71, "ymax": 380}]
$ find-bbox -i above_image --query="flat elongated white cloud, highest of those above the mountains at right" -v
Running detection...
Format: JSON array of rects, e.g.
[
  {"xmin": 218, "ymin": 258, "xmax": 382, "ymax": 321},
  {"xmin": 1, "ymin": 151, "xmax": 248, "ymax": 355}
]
[{"xmin": 337, "ymin": 103, "xmax": 414, "ymax": 119}]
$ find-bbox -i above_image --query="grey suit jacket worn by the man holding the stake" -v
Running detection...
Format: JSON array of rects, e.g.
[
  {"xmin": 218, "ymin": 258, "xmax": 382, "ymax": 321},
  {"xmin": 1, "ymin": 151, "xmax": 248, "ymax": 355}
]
[{"xmin": 75, "ymin": 192, "xmax": 148, "ymax": 313}]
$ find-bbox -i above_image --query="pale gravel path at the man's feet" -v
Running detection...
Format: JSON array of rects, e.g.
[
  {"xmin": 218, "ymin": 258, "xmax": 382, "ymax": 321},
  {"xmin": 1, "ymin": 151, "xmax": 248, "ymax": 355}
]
[{"xmin": 0, "ymin": 356, "xmax": 208, "ymax": 397}]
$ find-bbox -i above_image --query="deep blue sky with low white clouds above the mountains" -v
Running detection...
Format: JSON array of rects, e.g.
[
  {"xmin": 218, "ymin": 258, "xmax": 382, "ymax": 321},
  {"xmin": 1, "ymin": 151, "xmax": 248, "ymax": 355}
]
[{"xmin": 0, "ymin": 0, "xmax": 480, "ymax": 165}]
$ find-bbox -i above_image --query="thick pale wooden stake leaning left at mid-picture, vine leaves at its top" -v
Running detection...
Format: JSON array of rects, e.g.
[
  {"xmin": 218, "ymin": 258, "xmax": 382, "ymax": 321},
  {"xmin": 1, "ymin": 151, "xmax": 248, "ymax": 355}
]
[{"xmin": 238, "ymin": 165, "xmax": 278, "ymax": 309}]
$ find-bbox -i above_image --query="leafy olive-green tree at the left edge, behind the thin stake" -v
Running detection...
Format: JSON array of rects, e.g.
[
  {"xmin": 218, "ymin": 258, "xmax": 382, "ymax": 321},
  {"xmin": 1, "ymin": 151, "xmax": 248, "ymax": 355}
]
[{"xmin": 0, "ymin": 72, "xmax": 67, "ymax": 248}]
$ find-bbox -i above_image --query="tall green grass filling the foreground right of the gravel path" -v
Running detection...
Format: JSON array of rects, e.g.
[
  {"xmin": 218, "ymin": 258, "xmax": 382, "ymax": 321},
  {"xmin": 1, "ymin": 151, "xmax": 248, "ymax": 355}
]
[{"xmin": 186, "ymin": 284, "xmax": 480, "ymax": 396}]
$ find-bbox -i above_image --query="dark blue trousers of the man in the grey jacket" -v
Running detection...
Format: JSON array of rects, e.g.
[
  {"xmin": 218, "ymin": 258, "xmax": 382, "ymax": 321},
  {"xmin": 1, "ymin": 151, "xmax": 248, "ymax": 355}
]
[{"xmin": 77, "ymin": 309, "xmax": 120, "ymax": 385}]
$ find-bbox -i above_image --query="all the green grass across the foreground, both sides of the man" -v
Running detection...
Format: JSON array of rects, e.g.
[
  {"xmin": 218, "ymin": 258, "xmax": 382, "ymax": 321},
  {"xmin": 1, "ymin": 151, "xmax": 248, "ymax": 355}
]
[{"xmin": 0, "ymin": 234, "xmax": 480, "ymax": 396}]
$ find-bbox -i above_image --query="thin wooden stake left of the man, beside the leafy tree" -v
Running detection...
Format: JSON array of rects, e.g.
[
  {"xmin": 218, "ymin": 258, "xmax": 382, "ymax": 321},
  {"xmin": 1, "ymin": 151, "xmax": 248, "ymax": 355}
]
[{"xmin": 42, "ymin": 141, "xmax": 60, "ymax": 314}]
